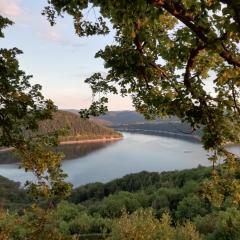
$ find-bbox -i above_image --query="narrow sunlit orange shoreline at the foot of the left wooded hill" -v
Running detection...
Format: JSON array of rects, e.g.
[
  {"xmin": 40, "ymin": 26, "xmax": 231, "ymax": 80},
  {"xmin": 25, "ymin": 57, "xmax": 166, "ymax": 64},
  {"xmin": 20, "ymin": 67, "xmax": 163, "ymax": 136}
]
[{"xmin": 0, "ymin": 136, "xmax": 123, "ymax": 153}]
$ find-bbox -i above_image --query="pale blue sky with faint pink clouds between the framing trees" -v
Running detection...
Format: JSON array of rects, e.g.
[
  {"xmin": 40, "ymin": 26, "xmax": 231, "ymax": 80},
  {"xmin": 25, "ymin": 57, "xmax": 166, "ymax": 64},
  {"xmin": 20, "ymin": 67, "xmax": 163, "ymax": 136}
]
[{"xmin": 0, "ymin": 0, "xmax": 133, "ymax": 110}]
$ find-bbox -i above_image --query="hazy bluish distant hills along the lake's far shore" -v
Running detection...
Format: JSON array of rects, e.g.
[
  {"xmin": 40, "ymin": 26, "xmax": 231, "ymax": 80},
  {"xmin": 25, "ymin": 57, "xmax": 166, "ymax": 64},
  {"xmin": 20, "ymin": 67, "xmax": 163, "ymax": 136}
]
[{"xmin": 63, "ymin": 109, "xmax": 202, "ymax": 142}]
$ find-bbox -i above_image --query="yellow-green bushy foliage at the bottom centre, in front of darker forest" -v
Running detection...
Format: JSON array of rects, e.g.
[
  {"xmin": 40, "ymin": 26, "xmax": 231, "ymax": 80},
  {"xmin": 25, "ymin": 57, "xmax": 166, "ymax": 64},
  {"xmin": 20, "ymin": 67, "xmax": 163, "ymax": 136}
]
[{"xmin": 110, "ymin": 209, "xmax": 202, "ymax": 240}]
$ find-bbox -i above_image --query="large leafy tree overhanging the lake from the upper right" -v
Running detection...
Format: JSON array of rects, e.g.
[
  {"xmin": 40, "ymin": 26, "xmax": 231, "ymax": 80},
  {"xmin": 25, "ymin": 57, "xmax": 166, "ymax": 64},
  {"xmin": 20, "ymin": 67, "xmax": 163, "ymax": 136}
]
[{"xmin": 43, "ymin": 0, "xmax": 240, "ymax": 202}]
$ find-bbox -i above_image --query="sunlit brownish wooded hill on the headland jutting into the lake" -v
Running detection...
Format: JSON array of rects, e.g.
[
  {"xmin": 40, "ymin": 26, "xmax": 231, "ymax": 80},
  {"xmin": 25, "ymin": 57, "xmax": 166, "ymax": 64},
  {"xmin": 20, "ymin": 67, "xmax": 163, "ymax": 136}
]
[{"xmin": 39, "ymin": 111, "xmax": 121, "ymax": 141}]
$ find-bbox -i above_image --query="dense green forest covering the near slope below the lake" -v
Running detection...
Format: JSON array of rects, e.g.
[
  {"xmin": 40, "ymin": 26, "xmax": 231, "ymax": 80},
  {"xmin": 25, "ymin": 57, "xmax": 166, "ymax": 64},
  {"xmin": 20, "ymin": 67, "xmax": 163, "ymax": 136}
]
[{"xmin": 0, "ymin": 166, "xmax": 240, "ymax": 240}]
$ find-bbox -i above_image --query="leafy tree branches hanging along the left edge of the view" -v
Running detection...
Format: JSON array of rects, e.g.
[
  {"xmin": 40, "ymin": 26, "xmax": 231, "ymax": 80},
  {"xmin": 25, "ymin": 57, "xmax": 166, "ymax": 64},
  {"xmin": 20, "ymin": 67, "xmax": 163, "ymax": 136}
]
[{"xmin": 0, "ymin": 16, "xmax": 70, "ymax": 202}]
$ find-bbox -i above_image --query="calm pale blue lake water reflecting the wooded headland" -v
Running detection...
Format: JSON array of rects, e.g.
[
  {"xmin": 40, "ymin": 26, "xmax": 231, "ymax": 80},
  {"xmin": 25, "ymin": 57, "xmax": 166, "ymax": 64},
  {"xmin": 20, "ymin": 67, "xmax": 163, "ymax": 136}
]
[{"xmin": 0, "ymin": 133, "xmax": 240, "ymax": 187}]
